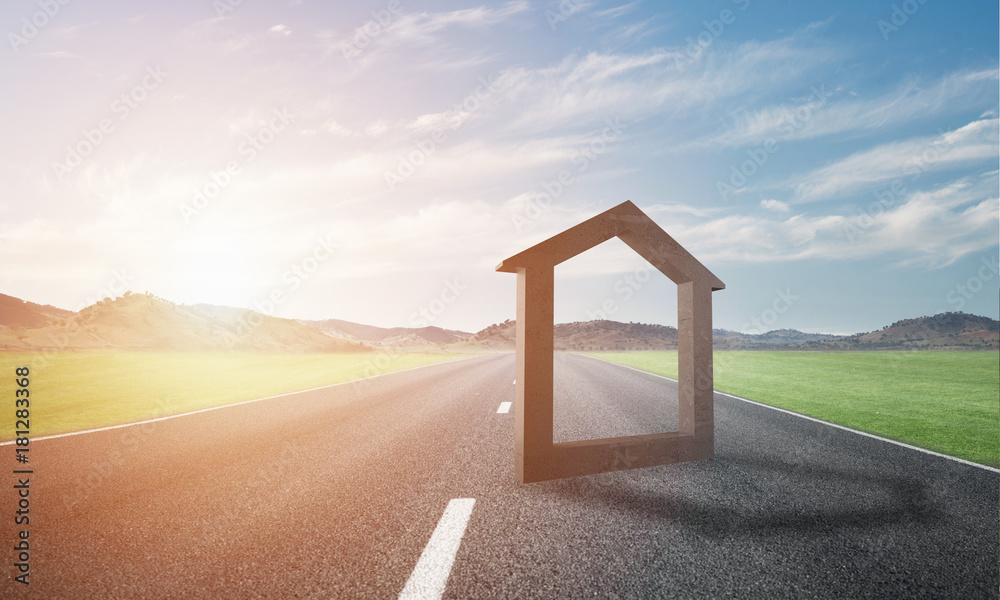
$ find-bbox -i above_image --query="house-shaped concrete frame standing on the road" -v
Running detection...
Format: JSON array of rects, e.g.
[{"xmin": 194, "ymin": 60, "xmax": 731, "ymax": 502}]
[{"xmin": 496, "ymin": 202, "xmax": 726, "ymax": 483}]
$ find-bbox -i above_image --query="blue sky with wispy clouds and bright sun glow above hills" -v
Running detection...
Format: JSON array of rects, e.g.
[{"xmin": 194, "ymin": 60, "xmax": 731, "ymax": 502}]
[{"xmin": 0, "ymin": 0, "xmax": 1000, "ymax": 333}]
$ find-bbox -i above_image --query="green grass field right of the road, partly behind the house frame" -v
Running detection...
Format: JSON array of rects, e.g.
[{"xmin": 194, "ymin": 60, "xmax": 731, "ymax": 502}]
[{"xmin": 591, "ymin": 351, "xmax": 1000, "ymax": 467}]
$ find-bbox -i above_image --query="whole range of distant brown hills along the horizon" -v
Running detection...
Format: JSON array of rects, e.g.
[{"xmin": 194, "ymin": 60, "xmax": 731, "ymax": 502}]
[{"xmin": 0, "ymin": 293, "xmax": 1000, "ymax": 352}]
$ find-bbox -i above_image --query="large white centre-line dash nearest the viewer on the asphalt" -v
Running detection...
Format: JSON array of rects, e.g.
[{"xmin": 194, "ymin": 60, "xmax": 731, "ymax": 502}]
[{"xmin": 399, "ymin": 498, "xmax": 476, "ymax": 600}]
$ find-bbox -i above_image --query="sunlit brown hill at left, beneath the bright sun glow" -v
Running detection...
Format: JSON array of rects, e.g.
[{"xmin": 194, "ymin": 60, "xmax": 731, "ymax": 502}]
[{"xmin": 0, "ymin": 293, "xmax": 370, "ymax": 352}]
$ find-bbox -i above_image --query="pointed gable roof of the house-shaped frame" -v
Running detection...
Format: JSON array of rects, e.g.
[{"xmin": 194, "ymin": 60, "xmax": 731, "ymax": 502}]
[{"xmin": 496, "ymin": 200, "xmax": 726, "ymax": 291}]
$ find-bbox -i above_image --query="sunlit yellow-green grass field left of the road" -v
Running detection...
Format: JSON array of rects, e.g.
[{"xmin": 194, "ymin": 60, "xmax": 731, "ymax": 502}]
[{"xmin": 0, "ymin": 351, "xmax": 467, "ymax": 441}]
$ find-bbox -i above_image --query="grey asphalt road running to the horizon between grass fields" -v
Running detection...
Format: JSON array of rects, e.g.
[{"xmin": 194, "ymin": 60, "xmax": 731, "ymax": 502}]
[{"xmin": 0, "ymin": 355, "xmax": 1000, "ymax": 600}]
